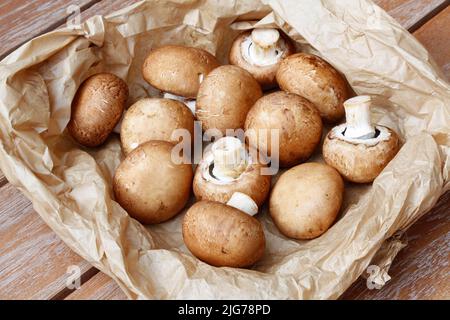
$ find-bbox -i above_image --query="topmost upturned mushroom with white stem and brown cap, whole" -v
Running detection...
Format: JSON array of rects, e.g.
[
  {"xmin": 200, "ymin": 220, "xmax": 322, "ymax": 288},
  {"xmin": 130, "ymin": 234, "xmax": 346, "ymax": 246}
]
[{"xmin": 229, "ymin": 28, "xmax": 295, "ymax": 88}]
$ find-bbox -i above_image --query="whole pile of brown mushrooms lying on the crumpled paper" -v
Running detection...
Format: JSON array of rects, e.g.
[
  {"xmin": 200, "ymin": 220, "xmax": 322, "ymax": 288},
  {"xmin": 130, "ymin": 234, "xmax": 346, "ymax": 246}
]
[{"xmin": 68, "ymin": 28, "xmax": 400, "ymax": 268}]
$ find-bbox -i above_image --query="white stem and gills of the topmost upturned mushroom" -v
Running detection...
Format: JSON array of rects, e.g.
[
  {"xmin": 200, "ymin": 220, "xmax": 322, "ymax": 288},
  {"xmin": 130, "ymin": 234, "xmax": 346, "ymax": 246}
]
[{"xmin": 241, "ymin": 29, "xmax": 286, "ymax": 67}]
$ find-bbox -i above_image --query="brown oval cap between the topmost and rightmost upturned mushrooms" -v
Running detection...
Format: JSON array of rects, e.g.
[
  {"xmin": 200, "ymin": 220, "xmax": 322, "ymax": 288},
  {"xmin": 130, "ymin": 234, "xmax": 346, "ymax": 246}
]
[{"xmin": 276, "ymin": 53, "xmax": 349, "ymax": 123}]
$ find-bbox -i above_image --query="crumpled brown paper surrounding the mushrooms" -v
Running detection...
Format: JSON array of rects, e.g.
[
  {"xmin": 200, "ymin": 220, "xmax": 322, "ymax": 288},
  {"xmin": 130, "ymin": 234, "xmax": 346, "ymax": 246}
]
[{"xmin": 0, "ymin": 0, "xmax": 450, "ymax": 299}]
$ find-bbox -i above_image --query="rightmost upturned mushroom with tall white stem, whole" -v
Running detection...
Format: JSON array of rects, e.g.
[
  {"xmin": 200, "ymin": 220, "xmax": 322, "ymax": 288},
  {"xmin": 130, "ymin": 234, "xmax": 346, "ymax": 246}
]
[{"xmin": 323, "ymin": 96, "xmax": 400, "ymax": 183}]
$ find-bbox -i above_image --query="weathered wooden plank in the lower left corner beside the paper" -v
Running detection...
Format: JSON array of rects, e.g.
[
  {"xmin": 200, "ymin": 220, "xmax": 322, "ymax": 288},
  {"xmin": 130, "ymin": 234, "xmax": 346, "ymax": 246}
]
[{"xmin": 0, "ymin": 184, "xmax": 91, "ymax": 300}]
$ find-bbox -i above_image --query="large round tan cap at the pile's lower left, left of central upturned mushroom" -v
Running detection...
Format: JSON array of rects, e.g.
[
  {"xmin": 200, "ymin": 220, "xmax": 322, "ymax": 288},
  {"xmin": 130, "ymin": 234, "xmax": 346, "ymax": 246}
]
[{"xmin": 113, "ymin": 141, "xmax": 193, "ymax": 224}]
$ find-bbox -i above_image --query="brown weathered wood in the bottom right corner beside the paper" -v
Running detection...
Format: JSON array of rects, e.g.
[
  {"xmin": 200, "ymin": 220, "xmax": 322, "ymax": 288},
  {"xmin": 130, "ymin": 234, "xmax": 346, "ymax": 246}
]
[{"xmin": 342, "ymin": 192, "xmax": 450, "ymax": 300}]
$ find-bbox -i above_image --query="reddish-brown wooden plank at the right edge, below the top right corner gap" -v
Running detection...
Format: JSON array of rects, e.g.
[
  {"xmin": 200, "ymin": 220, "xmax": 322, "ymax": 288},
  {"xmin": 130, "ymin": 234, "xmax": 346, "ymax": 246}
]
[{"xmin": 414, "ymin": 7, "xmax": 450, "ymax": 81}]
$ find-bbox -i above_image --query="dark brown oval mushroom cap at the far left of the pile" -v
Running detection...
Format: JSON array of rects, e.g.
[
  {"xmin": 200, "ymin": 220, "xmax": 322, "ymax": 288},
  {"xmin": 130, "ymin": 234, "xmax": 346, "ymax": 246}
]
[{"xmin": 67, "ymin": 73, "xmax": 128, "ymax": 147}]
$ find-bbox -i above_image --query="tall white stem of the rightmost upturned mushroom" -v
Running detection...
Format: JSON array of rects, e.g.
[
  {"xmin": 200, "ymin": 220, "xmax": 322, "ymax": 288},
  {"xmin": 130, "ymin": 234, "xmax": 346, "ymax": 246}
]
[{"xmin": 344, "ymin": 96, "xmax": 376, "ymax": 139}]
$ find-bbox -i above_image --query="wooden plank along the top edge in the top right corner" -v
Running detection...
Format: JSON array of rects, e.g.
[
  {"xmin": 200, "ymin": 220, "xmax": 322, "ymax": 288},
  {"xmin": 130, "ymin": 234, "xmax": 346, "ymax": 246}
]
[{"xmin": 374, "ymin": 0, "xmax": 448, "ymax": 32}]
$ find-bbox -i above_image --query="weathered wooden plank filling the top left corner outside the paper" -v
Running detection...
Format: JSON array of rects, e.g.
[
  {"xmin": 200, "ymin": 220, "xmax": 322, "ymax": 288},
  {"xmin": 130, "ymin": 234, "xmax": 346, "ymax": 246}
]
[{"xmin": 0, "ymin": 0, "xmax": 98, "ymax": 60}]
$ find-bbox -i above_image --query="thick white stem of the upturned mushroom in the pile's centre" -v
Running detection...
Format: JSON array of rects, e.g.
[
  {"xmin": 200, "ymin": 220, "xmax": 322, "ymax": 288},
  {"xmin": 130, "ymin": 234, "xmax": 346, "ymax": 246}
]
[{"xmin": 212, "ymin": 137, "xmax": 247, "ymax": 181}]
